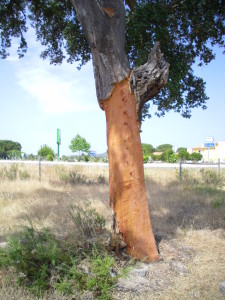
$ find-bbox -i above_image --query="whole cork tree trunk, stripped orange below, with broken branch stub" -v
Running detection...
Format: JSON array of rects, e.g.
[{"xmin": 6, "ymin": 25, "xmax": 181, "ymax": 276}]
[{"xmin": 71, "ymin": 0, "xmax": 169, "ymax": 261}]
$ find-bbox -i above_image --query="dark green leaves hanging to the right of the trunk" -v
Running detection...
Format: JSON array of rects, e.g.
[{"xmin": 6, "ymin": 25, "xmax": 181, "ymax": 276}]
[{"xmin": 126, "ymin": 0, "xmax": 225, "ymax": 118}]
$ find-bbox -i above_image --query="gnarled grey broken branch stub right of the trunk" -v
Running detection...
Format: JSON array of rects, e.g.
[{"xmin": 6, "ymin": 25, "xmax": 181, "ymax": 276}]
[{"xmin": 130, "ymin": 43, "xmax": 169, "ymax": 124}]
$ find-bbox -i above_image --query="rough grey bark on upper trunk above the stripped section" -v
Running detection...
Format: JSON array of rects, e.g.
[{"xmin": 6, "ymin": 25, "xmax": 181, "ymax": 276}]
[{"xmin": 71, "ymin": 0, "xmax": 130, "ymax": 102}]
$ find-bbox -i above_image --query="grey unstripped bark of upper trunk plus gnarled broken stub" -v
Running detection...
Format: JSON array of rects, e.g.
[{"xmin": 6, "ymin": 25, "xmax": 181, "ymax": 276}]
[{"xmin": 71, "ymin": 0, "xmax": 169, "ymax": 123}]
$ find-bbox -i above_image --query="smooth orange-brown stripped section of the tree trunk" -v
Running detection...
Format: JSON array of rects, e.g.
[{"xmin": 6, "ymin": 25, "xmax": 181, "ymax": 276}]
[{"xmin": 102, "ymin": 80, "xmax": 159, "ymax": 262}]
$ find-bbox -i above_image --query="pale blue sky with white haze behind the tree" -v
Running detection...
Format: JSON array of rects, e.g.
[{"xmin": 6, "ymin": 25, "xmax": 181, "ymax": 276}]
[{"xmin": 0, "ymin": 29, "xmax": 225, "ymax": 156}]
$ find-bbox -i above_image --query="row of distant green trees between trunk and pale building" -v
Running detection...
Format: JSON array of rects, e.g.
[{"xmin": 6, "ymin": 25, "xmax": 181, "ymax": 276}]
[{"xmin": 142, "ymin": 144, "xmax": 202, "ymax": 163}]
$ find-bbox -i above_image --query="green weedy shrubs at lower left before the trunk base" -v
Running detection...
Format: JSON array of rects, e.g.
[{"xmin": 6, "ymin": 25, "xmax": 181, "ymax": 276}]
[{"xmin": 0, "ymin": 218, "xmax": 125, "ymax": 300}]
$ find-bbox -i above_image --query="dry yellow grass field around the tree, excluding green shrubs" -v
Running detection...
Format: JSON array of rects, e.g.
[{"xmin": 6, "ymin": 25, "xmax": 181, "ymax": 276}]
[{"xmin": 0, "ymin": 164, "xmax": 225, "ymax": 300}]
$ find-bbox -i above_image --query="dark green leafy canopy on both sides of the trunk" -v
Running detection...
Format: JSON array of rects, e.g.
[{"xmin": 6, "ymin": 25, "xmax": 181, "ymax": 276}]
[{"xmin": 0, "ymin": 0, "xmax": 225, "ymax": 118}]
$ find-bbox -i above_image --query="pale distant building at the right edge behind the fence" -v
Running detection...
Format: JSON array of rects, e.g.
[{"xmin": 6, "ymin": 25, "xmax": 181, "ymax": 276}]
[{"xmin": 187, "ymin": 141, "xmax": 225, "ymax": 162}]
